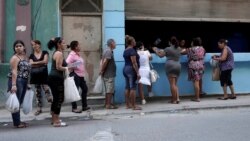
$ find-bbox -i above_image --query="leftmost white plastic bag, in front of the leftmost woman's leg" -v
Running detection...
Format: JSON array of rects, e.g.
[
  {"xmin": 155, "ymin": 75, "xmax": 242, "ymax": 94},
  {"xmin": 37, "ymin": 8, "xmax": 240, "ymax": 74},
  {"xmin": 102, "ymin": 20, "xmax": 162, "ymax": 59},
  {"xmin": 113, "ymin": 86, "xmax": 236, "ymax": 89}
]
[{"xmin": 5, "ymin": 93, "xmax": 20, "ymax": 113}]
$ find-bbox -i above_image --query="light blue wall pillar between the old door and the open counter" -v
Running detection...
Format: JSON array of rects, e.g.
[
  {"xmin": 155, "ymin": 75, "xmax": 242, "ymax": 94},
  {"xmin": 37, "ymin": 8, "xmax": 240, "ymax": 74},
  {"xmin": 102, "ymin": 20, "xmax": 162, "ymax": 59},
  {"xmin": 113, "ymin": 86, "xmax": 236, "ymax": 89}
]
[{"xmin": 103, "ymin": 0, "xmax": 125, "ymax": 102}]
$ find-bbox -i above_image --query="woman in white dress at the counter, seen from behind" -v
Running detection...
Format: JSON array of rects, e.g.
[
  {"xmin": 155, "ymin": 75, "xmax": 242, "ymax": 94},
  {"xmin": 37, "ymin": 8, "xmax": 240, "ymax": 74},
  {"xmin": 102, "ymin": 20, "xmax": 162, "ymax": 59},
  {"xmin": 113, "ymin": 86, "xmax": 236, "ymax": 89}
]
[{"xmin": 136, "ymin": 42, "xmax": 153, "ymax": 105}]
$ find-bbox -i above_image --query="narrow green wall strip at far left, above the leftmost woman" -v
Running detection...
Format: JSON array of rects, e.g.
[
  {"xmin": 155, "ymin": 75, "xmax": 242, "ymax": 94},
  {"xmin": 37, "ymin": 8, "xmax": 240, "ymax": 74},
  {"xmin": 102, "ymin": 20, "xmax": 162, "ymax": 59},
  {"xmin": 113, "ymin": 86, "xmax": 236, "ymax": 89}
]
[{"xmin": 4, "ymin": 0, "xmax": 16, "ymax": 63}]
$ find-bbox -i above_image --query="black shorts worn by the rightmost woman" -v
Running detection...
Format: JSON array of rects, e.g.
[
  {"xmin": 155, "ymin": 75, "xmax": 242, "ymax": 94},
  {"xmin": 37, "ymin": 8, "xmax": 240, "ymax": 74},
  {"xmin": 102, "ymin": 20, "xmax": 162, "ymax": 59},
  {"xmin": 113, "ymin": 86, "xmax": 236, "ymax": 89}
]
[{"xmin": 220, "ymin": 69, "xmax": 233, "ymax": 87}]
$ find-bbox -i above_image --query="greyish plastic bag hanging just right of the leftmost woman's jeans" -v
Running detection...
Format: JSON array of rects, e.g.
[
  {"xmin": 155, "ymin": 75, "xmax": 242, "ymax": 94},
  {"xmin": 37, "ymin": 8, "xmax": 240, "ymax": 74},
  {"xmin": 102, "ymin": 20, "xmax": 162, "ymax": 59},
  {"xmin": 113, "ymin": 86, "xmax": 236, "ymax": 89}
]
[{"xmin": 23, "ymin": 89, "xmax": 34, "ymax": 115}]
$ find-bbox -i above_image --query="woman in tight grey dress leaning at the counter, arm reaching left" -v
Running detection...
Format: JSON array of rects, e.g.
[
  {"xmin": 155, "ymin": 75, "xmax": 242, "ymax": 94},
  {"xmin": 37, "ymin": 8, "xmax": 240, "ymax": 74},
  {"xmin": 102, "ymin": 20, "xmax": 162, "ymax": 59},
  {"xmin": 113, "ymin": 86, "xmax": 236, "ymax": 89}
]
[{"xmin": 153, "ymin": 37, "xmax": 182, "ymax": 104}]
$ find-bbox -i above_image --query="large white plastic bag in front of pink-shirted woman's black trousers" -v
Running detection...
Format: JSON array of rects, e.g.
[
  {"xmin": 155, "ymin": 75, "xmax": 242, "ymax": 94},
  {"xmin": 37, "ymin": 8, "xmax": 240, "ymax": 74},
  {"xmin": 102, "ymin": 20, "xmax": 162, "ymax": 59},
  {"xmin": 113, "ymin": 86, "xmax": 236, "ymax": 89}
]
[{"xmin": 64, "ymin": 69, "xmax": 81, "ymax": 103}]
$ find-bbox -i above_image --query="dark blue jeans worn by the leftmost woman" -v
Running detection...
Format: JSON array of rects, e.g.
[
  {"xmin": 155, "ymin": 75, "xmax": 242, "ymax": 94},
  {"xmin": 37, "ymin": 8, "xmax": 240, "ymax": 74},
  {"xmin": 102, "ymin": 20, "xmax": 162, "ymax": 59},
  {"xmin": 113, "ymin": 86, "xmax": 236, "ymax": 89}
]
[{"xmin": 8, "ymin": 78, "xmax": 28, "ymax": 126}]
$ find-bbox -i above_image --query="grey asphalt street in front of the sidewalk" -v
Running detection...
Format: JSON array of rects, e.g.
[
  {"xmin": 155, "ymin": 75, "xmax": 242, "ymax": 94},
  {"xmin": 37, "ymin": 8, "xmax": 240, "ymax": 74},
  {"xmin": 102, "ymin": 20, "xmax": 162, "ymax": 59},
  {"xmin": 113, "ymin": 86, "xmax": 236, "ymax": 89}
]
[{"xmin": 0, "ymin": 108, "xmax": 250, "ymax": 141}]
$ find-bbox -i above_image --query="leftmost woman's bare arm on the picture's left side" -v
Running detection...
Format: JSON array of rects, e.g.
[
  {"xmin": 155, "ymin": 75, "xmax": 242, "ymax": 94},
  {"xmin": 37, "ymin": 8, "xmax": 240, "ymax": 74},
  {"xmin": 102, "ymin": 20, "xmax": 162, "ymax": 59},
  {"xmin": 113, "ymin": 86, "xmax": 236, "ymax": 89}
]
[{"xmin": 10, "ymin": 56, "xmax": 19, "ymax": 92}]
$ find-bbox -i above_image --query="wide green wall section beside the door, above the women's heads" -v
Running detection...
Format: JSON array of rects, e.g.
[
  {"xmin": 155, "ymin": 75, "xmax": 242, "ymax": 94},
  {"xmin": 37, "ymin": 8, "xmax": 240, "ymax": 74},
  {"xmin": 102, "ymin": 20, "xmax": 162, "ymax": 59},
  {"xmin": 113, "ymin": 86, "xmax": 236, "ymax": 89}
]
[{"xmin": 31, "ymin": 0, "xmax": 60, "ymax": 50}]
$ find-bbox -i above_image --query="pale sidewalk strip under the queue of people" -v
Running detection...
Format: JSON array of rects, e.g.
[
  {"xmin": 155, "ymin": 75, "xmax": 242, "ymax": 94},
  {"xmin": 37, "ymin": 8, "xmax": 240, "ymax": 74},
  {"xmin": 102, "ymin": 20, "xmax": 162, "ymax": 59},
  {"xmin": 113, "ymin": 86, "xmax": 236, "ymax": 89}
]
[{"xmin": 0, "ymin": 94, "xmax": 250, "ymax": 123}]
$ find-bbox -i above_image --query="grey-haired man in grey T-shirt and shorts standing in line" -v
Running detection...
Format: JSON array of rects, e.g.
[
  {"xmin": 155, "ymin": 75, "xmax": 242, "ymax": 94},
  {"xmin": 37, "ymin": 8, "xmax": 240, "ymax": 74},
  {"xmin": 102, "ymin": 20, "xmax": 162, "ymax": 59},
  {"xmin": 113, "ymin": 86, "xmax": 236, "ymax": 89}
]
[{"xmin": 100, "ymin": 39, "xmax": 117, "ymax": 109}]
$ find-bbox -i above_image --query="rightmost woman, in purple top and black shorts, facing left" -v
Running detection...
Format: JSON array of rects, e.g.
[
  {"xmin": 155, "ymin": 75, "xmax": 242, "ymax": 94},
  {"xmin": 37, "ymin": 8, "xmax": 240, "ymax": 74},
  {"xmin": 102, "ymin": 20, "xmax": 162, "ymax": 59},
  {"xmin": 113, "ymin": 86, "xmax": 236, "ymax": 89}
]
[{"xmin": 212, "ymin": 39, "xmax": 236, "ymax": 100}]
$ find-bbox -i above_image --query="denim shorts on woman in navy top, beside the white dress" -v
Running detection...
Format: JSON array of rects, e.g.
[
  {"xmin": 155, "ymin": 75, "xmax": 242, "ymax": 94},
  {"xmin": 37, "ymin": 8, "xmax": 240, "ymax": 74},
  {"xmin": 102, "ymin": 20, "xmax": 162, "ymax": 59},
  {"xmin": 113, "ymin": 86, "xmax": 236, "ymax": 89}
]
[{"xmin": 123, "ymin": 66, "xmax": 137, "ymax": 90}]
